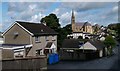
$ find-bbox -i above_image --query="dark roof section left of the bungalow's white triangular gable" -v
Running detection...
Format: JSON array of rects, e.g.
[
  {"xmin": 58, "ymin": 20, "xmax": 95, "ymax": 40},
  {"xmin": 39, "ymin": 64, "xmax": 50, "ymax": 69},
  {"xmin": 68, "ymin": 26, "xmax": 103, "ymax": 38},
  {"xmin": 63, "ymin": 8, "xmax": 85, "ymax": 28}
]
[{"xmin": 62, "ymin": 39, "xmax": 83, "ymax": 48}]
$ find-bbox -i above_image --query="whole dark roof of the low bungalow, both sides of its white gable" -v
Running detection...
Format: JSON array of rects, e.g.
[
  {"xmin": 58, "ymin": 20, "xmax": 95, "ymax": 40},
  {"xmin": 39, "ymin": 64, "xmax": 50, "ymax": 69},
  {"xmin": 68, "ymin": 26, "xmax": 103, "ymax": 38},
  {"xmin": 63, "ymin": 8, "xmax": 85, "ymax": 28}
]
[{"xmin": 62, "ymin": 39, "xmax": 105, "ymax": 50}]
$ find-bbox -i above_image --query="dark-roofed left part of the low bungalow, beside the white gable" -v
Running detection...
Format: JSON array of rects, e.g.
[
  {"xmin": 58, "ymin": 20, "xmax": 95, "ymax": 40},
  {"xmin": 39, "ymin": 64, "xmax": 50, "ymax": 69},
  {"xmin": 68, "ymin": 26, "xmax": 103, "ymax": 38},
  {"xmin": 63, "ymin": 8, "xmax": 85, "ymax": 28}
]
[{"xmin": 59, "ymin": 39, "xmax": 85, "ymax": 60}]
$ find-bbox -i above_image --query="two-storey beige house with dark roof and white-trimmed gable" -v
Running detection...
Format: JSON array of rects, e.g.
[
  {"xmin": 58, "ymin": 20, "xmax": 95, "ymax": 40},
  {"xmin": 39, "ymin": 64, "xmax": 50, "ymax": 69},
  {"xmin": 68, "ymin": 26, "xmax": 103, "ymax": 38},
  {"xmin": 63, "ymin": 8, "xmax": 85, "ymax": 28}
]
[{"xmin": 3, "ymin": 21, "xmax": 57, "ymax": 57}]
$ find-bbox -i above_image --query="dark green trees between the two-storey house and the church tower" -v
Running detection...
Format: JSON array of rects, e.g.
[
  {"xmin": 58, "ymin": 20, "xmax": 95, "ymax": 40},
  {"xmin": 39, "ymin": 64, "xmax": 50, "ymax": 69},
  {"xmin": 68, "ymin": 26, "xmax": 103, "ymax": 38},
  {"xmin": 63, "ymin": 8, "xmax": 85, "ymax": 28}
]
[{"xmin": 40, "ymin": 13, "xmax": 72, "ymax": 50}]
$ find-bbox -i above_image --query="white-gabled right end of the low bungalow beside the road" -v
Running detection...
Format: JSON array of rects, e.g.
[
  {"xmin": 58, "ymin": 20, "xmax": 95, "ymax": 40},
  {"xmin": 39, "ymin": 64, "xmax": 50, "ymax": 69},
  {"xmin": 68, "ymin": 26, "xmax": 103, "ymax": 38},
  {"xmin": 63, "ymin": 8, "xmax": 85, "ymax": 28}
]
[{"xmin": 79, "ymin": 40, "xmax": 105, "ymax": 57}]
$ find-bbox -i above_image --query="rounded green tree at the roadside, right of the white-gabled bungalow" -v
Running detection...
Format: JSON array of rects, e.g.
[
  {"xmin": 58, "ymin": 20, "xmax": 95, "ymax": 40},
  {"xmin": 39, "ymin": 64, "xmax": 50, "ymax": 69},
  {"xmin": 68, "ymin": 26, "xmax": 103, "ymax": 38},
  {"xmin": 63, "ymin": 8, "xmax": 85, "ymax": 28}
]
[{"xmin": 104, "ymin": 35, "xmax": 116, "ymax": 55}]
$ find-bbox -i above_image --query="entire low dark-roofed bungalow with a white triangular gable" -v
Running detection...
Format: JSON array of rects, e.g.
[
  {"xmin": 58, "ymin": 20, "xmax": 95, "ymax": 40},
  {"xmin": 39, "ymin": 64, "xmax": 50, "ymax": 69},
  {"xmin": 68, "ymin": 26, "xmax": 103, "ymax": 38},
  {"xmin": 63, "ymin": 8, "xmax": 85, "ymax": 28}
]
[{"xmin": 60, "ymin": 39, "xmax": 105, "ymax": 60}]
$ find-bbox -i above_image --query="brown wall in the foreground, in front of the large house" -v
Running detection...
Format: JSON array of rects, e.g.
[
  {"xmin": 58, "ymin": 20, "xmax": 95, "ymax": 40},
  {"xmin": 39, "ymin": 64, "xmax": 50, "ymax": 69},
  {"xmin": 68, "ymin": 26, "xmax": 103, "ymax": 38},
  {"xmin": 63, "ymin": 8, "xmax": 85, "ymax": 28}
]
[{"xmin": 2, "ymin": 56, "xmax": 47, "ymax": 71}]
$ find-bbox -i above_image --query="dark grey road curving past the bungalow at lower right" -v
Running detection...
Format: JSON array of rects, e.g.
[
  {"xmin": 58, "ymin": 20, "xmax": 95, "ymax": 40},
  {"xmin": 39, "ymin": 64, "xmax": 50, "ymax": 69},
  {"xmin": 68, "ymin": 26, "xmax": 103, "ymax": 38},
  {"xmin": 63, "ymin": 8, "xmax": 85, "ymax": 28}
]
[{"xmin": 48, "ymin": 42, "xmax": 120, "ymax": 69}]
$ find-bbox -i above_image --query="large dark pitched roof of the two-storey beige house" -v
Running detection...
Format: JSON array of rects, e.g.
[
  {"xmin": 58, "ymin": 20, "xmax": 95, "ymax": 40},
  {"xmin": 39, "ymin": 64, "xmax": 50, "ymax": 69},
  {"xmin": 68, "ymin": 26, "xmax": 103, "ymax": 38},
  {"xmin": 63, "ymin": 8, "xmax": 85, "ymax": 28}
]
[{"xmin": 16, "ymin": 21, "xmax": 57, "ymax": 36}]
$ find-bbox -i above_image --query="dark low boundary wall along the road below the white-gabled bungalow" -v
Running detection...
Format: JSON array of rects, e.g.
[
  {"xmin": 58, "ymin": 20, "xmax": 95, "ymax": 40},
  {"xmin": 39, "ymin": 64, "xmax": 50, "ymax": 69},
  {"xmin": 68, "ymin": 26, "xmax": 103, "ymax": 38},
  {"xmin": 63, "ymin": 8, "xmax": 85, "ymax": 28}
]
[{"xmin": 59, "ymin": 50, "xmax": 99, "ymax": 60}]
